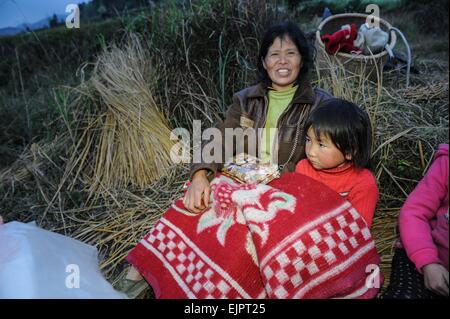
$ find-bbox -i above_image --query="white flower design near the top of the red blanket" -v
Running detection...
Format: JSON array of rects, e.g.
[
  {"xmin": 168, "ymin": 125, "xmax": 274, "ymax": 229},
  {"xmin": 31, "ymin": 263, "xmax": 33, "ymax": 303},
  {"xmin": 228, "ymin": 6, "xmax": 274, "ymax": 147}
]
[{"xmin": 197, "ymin": 176, "xmax": 296, "ymax": 257}]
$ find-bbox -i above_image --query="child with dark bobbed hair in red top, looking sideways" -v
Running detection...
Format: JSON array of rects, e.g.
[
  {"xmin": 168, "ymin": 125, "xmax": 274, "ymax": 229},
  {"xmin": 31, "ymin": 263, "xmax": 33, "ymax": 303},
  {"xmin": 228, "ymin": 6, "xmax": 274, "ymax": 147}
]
[{"xmin": 295, "ymin": 99, "xmax": 378, "ymax": 228}]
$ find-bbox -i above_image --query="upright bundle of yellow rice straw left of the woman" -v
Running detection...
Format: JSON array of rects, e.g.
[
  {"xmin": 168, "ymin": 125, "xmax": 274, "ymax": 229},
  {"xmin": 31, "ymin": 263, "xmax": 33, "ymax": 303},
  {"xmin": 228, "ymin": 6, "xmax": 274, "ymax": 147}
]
[{"xmin": 77, "ymin": 36, "xmax": 173, "ymax": 194}]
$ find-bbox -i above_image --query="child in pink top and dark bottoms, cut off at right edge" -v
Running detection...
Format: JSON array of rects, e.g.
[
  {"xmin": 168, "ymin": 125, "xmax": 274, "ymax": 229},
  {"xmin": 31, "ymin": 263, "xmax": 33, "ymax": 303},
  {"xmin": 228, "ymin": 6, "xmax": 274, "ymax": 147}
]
[{"xmin": 383, "ymin": 144, "xmax": 449, "ymax": 299}]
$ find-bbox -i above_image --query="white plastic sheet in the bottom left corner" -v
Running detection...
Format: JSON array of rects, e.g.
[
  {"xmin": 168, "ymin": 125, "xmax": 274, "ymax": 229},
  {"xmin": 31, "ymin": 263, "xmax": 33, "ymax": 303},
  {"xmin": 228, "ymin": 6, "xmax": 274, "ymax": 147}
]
[{"xmin": 0, "ymin": 222, "xmax": 126, "ymax": 299}]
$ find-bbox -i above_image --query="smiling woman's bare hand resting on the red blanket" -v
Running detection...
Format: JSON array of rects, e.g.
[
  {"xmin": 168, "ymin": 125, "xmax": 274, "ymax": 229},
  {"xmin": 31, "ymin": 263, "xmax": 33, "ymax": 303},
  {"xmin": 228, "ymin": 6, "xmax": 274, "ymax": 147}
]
[{"xmin": 183, "ymin": 169, "xmax": 211, "ymax": 214}]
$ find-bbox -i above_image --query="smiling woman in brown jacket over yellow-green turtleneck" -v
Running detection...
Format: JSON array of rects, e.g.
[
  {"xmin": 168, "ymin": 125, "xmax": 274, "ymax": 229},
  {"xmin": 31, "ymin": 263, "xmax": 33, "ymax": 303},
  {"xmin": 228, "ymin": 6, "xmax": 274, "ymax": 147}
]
[{"xmin": 183, "ymin": 22, "xmax": 331, "ymax": 213}]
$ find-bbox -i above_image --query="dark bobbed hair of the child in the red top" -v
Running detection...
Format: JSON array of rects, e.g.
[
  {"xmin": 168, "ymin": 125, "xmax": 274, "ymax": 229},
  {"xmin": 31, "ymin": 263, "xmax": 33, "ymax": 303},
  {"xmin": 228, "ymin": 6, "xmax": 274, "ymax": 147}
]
[{"xmin": 305, "ymin": 98, "xmax": 372, "ymax": 168}]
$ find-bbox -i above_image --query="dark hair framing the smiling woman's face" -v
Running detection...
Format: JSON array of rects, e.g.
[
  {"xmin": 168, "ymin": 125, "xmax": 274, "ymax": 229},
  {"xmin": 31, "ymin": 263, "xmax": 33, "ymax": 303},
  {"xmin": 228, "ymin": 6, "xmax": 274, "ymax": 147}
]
[{"xmin": 258, "ymin": 21, "xmax": 312, "ymax": 86}]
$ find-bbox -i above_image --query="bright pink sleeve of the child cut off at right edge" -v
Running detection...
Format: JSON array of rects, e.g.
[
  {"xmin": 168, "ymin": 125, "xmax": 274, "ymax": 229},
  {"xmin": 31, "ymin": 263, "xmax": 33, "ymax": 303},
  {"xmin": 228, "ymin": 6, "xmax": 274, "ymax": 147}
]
[{"xmin": 399, "ymin": 156, "xmax": 448, "ymax": 272}]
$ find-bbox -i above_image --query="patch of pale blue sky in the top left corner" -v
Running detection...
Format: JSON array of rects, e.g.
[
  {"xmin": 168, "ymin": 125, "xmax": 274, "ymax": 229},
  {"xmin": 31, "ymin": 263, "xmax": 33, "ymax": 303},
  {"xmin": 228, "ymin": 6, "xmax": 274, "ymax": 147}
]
[{"xmin": 0, "ymin": 0, "xmax": 89, "ymax": 28}]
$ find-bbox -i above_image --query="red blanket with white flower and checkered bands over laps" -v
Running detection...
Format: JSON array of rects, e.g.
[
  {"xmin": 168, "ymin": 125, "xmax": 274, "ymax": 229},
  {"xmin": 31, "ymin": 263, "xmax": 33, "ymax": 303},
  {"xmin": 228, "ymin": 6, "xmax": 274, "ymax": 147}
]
[{"xmin": 127, "ymin": 173, "xmax": 381, "ymax": 299}]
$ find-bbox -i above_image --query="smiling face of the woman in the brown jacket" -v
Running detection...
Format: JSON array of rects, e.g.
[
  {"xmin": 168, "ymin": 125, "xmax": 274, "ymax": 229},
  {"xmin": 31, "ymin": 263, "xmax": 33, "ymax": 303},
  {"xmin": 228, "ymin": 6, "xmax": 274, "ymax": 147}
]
[{"xmin": 263, "ymin": 36, "xmax": 302, "ymax": 91}]
